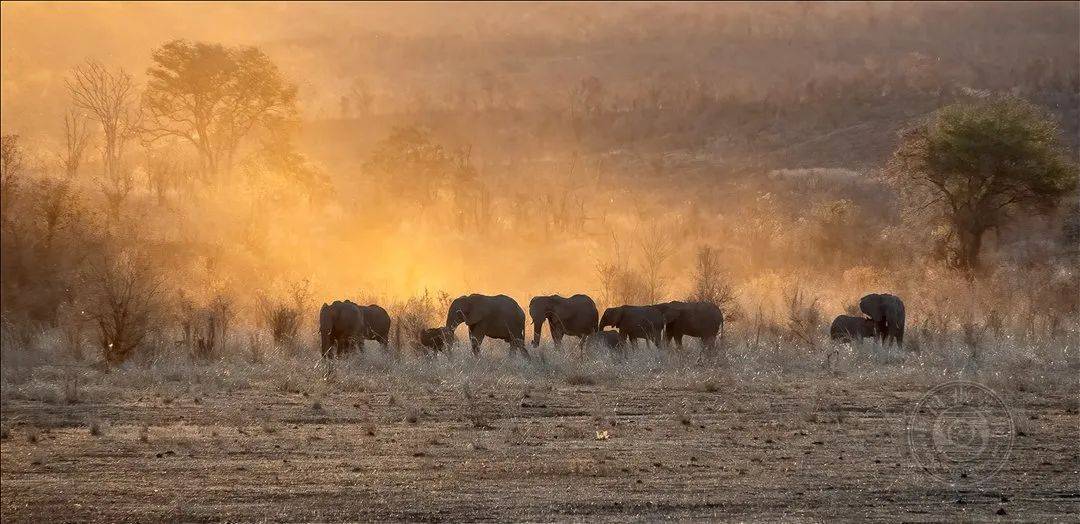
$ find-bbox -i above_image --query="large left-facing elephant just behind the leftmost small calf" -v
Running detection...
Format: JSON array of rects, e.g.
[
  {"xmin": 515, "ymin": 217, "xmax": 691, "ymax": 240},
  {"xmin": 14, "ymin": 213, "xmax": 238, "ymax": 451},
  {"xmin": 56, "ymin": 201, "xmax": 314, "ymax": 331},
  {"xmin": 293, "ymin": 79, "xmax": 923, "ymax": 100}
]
[{"xmin": 445, "ymin": 294, "xmax": 529, "ymax": 358}]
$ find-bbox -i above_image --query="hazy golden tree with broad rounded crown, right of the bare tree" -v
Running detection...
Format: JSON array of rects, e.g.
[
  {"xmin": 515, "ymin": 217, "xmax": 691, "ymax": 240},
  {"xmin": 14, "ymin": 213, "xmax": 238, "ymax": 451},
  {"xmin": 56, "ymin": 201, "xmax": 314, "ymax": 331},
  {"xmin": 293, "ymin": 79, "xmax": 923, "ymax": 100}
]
[{"xmin": 143, "ymin": 40, "xmax": 296, "ymax": 176}]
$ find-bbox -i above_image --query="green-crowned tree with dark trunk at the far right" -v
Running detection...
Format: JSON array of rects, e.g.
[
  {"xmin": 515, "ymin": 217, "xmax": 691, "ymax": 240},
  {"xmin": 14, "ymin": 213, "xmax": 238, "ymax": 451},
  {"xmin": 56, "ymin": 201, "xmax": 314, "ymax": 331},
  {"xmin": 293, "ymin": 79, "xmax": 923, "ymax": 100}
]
[{"xmin": 889, "ymin": 97, "xmax": 1077, "ymax": 271}]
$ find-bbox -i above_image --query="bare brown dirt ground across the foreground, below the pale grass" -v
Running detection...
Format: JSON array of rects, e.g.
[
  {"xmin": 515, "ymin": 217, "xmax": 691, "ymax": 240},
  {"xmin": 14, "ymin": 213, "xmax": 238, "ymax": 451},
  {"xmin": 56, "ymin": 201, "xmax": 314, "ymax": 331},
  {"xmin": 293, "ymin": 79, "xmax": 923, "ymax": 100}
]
[{"xmin": 0, "ymin": 379, "xmax": 1080, "ymax": 522}]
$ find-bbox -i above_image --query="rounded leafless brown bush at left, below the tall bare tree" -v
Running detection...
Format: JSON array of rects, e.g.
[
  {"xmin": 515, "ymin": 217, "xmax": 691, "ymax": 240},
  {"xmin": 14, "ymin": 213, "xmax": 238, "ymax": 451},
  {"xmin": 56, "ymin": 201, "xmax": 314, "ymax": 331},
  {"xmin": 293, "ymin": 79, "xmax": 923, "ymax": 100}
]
[{"xmin": 84, "ymin": 252, "xmax": 163, "ymax": 365}]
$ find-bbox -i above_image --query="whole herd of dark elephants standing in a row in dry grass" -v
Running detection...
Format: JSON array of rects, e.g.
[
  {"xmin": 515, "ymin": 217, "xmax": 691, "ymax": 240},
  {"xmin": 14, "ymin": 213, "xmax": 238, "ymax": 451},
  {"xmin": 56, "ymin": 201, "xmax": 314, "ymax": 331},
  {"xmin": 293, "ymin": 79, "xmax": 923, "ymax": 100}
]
[{"xmin": 319, "ymin": 294, "xmax": 904, "ymax": 357}]
